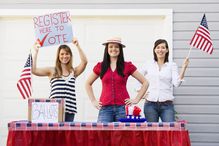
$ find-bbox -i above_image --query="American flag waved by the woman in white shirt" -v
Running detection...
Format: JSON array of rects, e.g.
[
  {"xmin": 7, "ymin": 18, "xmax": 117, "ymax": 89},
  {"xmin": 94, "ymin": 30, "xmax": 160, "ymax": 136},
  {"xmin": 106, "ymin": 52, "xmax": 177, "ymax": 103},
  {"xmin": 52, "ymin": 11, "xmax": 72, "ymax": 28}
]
[{"xmin": 190, "ymin": 14, "xmax": 214, "ymax": 54}]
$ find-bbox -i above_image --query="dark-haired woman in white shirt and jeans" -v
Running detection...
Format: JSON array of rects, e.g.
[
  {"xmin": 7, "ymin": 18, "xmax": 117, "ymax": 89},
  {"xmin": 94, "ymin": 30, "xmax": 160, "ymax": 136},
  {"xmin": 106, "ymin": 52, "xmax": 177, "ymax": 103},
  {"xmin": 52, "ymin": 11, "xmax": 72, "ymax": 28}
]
[{"xmin": 136, "ymin": 39, "xmax": 189, "ymax": 122}]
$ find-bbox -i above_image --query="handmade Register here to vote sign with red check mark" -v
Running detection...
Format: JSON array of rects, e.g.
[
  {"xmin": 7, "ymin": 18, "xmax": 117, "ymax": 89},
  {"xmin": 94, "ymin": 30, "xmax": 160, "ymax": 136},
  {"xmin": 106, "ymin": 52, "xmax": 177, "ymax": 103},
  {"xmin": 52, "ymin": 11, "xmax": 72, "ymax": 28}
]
[{"xmin": 33, "ymin": 11, "xmax": 73, "ymax": 47}]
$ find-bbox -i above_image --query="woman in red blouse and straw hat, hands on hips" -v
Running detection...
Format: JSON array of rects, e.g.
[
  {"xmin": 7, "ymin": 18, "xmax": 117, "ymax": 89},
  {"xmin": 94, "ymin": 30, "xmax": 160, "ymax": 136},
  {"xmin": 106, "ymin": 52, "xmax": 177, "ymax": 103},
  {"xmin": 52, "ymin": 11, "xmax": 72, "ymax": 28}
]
[{"xmin": 86, "ymin": 38, "xmax": 148, "ymax": 122}]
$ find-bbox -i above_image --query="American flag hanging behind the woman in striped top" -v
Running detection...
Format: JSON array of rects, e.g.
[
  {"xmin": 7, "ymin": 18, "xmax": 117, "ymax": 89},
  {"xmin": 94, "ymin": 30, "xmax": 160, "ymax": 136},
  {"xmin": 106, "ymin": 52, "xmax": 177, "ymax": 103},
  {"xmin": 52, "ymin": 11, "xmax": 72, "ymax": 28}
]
[{"xmin": 17, "ymin": 54, "xmax": 32, "ymax": 99}]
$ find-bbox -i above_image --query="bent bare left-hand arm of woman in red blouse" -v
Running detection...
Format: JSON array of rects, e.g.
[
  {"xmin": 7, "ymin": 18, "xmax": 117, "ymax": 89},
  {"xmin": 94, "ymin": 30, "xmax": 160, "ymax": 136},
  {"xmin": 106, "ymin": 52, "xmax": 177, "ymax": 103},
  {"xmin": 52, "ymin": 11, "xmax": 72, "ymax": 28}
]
[{"xmin": 85, "ymin": 72, "xmax": 102, "ymax": 109}]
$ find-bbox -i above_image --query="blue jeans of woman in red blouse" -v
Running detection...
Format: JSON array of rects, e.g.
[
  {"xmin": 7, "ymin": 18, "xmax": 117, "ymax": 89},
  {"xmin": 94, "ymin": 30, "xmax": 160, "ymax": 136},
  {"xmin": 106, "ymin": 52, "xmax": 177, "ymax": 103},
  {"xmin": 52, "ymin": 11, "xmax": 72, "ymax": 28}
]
[{"xmin": 97, "ymin": 105, "xmax": 126, "ymax": 123}]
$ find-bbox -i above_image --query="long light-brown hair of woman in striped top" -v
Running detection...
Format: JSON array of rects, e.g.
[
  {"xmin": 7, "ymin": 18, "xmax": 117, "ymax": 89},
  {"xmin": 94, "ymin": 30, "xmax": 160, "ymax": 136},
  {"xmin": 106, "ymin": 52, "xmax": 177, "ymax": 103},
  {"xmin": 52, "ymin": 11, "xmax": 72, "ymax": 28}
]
[{"xmin": 53, "ymin": 45, "xmax": 73, "ymax": 78}]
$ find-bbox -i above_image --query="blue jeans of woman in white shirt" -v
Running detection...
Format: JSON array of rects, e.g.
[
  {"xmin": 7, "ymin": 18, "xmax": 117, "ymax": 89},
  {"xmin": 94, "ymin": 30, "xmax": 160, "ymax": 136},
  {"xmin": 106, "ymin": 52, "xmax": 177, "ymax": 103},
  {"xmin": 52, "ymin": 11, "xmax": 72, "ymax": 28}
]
[{"xmin": 144, "ymin": 101, "xmax": 175, "ymax": 122}]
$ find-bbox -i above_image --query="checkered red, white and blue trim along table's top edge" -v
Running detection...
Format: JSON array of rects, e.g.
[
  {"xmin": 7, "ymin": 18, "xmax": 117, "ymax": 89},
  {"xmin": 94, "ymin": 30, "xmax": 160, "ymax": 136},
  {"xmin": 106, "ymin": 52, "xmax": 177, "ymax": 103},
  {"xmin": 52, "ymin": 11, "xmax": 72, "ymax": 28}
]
[{"xmin": 8, "ymin": 121, "xmax": 186, "ymax": 131}]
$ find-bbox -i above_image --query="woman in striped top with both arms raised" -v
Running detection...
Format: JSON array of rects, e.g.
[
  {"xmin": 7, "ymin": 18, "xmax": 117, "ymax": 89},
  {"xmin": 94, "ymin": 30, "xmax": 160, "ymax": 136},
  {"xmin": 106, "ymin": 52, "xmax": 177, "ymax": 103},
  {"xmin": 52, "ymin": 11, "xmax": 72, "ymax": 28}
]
[{"xmin": 32, "ymin": 38, "xmax": 87, "ymax": 122}]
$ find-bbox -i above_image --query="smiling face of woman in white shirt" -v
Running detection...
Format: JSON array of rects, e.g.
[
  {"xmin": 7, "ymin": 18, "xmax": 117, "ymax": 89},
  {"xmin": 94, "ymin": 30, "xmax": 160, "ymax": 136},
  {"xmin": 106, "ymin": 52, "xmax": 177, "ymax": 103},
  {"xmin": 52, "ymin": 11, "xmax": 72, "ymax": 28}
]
[{"xmin": 154, "ymin": 43, "xmax": 169, "ymax": 59}]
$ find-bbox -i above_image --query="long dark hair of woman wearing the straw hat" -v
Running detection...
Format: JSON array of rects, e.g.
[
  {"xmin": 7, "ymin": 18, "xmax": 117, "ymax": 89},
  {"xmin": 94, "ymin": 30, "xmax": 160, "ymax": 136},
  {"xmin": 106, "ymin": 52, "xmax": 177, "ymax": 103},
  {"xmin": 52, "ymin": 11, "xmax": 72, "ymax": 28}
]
[{"xmin": 100, "ymin": 44, "xmax": 125, "ymax": 79}]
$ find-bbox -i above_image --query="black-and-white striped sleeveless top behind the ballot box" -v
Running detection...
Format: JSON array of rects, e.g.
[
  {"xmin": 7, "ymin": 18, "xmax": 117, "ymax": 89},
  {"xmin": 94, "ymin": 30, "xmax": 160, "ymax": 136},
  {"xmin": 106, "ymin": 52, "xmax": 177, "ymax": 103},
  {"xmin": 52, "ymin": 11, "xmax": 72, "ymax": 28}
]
[{"xmin": 50, "ymin": 74, "xmax": 77, "ymax": 113}]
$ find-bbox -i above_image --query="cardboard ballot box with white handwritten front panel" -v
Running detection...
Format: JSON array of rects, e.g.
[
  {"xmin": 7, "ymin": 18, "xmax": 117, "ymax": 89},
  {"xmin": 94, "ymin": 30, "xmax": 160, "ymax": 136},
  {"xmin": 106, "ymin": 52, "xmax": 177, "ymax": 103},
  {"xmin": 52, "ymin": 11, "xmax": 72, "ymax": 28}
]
[{"xmin": 28, "ymin": 99, "xmax": 65, "ymax": 123}]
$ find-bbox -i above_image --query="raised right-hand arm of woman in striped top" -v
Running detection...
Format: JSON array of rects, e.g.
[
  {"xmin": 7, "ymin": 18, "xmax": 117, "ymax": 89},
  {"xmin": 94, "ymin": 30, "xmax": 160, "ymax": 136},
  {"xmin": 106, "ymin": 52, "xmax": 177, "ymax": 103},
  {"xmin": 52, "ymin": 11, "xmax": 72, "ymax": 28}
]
[{"xmin": 72, "ymin": 38, "xmax": 87, "ymax": 77}]
